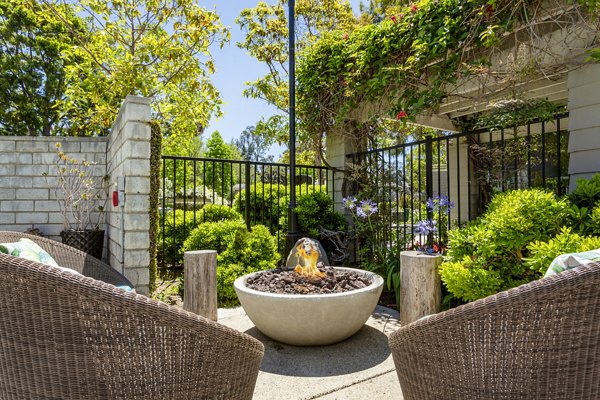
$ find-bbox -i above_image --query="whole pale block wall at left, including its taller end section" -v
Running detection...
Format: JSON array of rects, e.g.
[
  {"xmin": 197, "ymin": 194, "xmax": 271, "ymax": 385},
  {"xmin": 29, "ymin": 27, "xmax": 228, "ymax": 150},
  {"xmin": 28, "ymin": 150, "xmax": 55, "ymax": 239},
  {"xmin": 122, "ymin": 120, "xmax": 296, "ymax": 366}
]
[{"xmin": 0, "ymin": 96, "xmax": 151, "ymax": 294}]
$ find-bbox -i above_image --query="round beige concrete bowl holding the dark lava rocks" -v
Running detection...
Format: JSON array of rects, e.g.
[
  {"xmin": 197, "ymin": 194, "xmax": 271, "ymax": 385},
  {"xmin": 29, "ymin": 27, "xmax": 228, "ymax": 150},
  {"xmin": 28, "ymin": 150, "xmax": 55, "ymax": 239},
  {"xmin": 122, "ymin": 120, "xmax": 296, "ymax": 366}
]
[{"xmin": 234, "ymin": 267, "xmax": 383, "ymax": 346}]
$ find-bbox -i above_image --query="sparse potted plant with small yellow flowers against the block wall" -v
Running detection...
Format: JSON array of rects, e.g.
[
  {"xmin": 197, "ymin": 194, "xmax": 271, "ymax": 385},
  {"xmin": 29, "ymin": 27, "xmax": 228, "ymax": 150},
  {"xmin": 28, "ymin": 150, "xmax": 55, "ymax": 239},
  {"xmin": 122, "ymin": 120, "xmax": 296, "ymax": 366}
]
[{"xmin": 43, "ymin": 143, "xmax": 108, "ymax": 231}]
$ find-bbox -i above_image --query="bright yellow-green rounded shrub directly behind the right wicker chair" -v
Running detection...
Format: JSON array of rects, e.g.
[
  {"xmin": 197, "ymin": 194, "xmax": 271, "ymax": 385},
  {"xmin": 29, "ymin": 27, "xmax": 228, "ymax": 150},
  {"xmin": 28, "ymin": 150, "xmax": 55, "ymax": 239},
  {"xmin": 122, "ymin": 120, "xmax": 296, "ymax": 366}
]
[{"xmin": 440, "ymin": 189, "xmax": 568, "ymax": 301}]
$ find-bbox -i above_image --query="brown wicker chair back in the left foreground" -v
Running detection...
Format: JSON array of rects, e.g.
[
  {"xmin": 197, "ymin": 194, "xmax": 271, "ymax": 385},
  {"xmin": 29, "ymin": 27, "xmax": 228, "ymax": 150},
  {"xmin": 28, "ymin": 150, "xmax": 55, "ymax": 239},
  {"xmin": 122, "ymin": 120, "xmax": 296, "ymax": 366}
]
[{"xmin": 0, "ymin": 240, "xmax": 264, "ymax": 400}]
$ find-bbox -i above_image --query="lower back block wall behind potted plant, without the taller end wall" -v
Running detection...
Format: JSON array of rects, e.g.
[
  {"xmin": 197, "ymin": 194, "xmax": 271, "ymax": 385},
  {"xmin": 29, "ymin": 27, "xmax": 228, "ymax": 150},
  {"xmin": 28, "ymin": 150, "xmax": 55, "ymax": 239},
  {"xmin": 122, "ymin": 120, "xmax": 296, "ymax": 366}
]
[{"xmin": 0, "ymin": 136, "xmax": 108, "ymax": 241}]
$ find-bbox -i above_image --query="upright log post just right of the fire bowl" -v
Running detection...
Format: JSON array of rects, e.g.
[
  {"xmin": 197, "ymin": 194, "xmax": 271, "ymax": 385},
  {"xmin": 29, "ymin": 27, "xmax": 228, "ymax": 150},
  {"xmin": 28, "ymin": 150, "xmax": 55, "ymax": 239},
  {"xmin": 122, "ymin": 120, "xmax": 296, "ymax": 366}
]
[{"xmin": 400, "ymin": 251, "xmax": 442, "ymax": 325}]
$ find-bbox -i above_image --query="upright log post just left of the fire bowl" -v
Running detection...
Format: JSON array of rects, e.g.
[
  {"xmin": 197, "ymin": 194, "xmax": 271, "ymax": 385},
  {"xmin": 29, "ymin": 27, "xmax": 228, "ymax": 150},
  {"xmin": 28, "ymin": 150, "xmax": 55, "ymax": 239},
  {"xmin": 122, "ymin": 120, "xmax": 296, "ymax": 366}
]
[{"xmin": 183, "ymin": 250, "xmax": 217, "ymax": 321}]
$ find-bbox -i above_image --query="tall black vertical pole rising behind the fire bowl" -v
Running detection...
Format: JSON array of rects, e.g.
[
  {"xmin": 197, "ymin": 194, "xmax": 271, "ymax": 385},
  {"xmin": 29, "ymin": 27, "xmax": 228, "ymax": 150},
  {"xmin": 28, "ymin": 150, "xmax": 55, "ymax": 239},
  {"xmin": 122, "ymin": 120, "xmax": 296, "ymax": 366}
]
[{"xmin": 286, "ymin": 0, "xmax": 300, "ymax": 254}]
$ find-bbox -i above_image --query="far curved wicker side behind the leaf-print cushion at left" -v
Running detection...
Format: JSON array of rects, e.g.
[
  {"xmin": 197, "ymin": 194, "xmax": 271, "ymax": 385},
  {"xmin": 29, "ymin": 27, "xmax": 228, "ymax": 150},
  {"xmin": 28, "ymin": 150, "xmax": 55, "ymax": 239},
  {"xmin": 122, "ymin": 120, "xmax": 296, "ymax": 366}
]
[{"xmin": 0, "ymin": 231, "xmax": 133, "ymax": 287}]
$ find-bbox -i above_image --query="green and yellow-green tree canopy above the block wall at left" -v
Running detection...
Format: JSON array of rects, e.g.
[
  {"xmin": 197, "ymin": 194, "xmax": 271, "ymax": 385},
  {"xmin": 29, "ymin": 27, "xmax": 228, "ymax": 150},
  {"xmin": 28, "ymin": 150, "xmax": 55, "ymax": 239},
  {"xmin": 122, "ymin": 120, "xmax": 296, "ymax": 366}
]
[{"xmin": 0, "ymin": 0, "xmax": 229, "ymax": 146}]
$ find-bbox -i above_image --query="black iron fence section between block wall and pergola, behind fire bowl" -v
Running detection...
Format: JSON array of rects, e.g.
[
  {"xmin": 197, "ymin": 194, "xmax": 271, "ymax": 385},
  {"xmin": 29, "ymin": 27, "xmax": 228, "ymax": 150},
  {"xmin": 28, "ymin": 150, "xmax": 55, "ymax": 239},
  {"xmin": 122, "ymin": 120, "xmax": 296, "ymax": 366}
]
[{"xmin": 158, "ymin": 155, "xmax": 335, "ymax": 276}]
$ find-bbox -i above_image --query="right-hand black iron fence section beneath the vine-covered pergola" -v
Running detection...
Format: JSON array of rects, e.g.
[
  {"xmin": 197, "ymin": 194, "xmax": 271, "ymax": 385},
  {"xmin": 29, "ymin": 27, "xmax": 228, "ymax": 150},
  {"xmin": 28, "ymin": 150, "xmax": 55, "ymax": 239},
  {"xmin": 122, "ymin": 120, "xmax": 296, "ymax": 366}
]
[{"xmin": 348, "ymin": 114, "xmax": 569, "ymax": 260}]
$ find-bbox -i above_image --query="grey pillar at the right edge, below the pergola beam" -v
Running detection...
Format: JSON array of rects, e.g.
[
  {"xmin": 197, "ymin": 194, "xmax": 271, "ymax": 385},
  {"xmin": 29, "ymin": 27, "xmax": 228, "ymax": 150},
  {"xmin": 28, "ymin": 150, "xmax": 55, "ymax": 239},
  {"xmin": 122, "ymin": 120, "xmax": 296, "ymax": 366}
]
[{"xmin": 567, "ymin": 64, "xmax": 600, "ymax": 192}]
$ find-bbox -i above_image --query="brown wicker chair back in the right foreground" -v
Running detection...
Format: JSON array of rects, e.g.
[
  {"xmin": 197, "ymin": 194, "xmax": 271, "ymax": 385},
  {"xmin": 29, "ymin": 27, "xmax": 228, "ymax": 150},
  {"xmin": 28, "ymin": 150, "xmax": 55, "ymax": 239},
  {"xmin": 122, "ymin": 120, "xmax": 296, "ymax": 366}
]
[{"xmin": 389, "ymin": 263, "xmax": 600, "ymax": 400}]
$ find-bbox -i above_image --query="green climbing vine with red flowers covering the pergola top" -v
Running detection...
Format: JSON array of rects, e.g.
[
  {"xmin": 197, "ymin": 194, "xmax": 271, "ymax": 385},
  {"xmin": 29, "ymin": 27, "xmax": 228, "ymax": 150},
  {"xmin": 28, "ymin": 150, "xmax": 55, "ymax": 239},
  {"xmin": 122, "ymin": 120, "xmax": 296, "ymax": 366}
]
[{"xmin": 297, "ymin": 0, "xmax": 598, "ymax": 145}]
